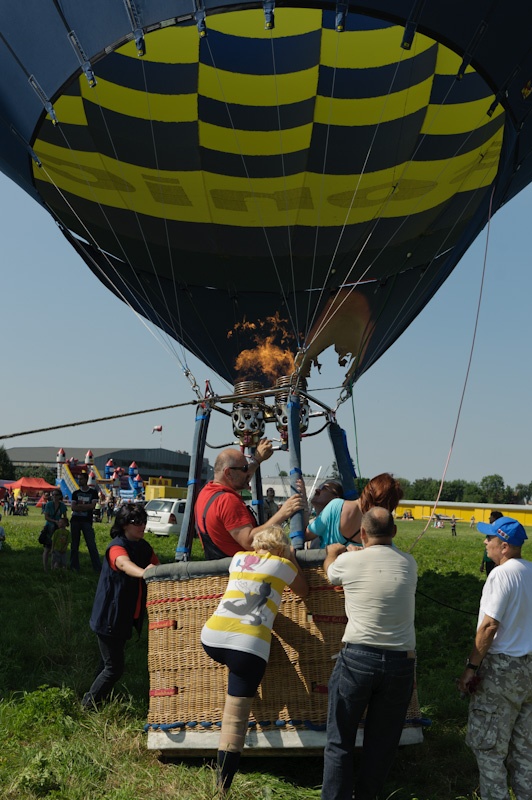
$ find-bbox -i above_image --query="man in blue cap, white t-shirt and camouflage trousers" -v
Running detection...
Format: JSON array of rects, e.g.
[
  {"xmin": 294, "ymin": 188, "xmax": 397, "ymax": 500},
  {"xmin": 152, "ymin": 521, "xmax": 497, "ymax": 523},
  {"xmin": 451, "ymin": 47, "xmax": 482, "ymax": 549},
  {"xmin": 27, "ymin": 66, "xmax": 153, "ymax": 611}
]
[{"xmin": 459, "ymin": 517, "xmax": 532, "ymax": 800}]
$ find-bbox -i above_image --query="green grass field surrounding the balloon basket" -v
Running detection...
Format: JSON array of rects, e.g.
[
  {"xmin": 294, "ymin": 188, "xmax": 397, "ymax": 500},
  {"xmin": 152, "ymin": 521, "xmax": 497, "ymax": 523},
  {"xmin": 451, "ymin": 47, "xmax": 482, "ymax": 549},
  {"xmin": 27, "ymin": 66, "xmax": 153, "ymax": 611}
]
[{"xmin": 0, "ymin": 509, "xmax": 532, "ymax": 800}]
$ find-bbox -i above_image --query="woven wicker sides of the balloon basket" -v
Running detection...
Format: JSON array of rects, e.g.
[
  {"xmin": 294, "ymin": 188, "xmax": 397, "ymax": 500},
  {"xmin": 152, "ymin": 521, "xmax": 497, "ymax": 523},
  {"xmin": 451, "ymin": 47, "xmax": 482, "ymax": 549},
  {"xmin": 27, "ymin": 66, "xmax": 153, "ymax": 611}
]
[{"xmin": 147, "ymin": 567, "xmax": 420, "ymax": 732}]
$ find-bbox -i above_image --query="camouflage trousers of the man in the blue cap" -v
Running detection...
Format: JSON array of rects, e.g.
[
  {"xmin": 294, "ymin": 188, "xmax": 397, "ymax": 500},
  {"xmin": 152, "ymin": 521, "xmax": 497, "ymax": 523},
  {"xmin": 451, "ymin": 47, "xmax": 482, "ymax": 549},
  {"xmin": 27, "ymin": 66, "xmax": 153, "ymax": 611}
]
[{"xmin": 466, "ymin": 654, "xmax": 532, "ymax": 800}]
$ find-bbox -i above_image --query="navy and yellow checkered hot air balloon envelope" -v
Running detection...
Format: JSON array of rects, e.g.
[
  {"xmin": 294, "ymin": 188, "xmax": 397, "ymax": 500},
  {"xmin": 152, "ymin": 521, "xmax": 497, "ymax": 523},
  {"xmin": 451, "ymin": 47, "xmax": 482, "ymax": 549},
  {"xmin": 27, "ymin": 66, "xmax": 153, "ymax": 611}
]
[{"xmin": 0, "ymin": 0, "xmax": 532, "ymax": 381}]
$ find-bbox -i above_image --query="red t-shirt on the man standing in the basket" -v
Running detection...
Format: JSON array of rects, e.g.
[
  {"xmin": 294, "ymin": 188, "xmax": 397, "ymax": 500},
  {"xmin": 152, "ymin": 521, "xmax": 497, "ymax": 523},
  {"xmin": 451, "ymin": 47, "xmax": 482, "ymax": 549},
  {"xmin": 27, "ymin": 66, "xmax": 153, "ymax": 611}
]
[{"xmin": 194, "ymin": 481, "xmax": 257, "ymax": 556}]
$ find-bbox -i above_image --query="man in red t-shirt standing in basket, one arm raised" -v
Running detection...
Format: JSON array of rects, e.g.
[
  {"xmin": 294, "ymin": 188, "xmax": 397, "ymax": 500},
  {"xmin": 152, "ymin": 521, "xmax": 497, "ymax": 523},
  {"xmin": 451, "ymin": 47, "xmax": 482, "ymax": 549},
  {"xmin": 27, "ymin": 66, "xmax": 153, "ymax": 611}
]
[{"xmin": 195, "ymin": 439, "xmax": 304, "ymax": 559}]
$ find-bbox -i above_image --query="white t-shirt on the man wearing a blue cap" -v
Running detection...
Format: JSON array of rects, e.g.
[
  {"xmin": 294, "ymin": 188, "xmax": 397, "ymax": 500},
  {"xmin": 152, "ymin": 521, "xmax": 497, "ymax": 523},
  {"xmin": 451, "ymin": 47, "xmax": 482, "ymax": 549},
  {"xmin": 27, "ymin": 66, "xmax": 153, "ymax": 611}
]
[{"xmin": 478, "ymin": 558, "xmax": 532, "ymax": 656}]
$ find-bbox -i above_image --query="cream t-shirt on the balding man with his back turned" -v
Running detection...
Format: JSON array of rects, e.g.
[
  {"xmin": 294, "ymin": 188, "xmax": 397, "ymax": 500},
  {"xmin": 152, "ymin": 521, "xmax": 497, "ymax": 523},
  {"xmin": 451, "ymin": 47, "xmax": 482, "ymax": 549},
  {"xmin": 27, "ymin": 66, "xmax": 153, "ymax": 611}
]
[{"xmin": 327, "ymin": 545, "xmax": 417, "ymax": 650}]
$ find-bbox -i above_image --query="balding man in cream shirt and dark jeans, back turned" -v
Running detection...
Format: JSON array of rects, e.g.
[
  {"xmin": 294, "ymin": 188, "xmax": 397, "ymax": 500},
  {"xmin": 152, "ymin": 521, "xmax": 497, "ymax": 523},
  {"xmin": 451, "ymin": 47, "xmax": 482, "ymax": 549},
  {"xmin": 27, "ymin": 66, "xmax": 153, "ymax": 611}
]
[{"xmin": 322, "ymin": 506, "xmax": 417, "ymax": 800}]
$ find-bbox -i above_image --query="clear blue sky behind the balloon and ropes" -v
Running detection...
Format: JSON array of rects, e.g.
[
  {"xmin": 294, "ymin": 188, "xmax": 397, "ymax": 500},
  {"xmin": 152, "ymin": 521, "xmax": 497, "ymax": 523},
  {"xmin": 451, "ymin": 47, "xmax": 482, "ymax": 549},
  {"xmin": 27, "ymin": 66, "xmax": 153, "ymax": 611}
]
[{"xmin": 0, "ymin": 175, "xmax": 532, "ymax": 486}]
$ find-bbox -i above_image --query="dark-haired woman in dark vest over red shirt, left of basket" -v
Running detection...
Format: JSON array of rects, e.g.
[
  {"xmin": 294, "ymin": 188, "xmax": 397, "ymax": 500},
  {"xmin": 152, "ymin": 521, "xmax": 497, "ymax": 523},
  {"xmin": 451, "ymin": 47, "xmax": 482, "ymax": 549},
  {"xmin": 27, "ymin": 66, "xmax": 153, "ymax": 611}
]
[{"xmin": 82, "ymin": 503, "xmax": 159, "ymax": 708}]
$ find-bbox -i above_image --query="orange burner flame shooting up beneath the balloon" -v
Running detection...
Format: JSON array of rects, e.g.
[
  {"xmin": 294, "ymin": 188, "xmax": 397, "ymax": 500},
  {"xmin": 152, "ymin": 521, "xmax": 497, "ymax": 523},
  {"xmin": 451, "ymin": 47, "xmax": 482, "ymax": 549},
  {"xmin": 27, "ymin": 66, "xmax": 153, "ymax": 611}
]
[{"xmin": 227, "ymin": 312, "xmax": 295, "ymax": 382}]
